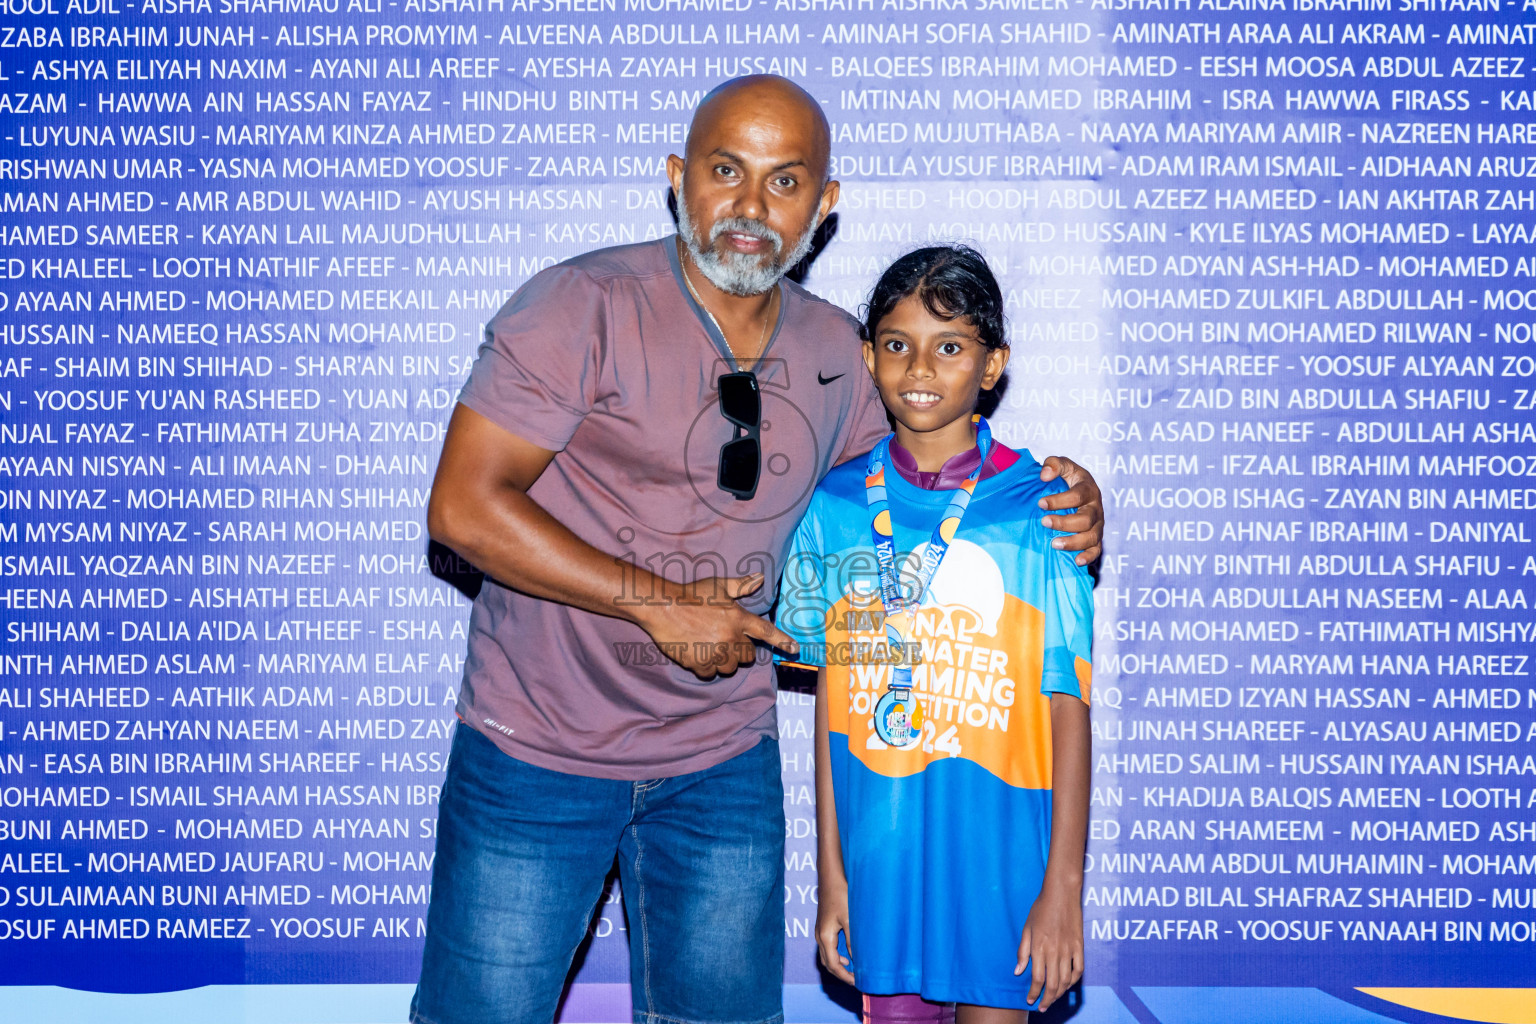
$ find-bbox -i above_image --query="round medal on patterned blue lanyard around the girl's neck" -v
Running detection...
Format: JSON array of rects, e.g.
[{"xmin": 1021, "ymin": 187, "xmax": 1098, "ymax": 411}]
[{"xmin": 865, "ymin": 416, "xmax": 992, "ymax": 749}]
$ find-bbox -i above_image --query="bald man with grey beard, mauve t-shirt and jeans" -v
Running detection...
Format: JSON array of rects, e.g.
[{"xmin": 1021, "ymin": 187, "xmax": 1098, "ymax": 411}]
[{"xmin": 412, "ymin": 77, "xmax": 1101, "ymax": 1024}]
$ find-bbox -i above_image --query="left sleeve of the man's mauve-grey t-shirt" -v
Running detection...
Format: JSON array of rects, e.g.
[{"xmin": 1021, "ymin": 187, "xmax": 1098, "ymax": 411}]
[{"xmin": 459, "ymin": 266, "xmax": 607, "ymax": 451}]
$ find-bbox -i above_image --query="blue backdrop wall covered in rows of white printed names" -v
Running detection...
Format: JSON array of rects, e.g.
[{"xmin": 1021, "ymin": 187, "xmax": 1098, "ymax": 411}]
[{"xmin": 0, "ymin": 0, "xmax": 1536, "ymax": 1022}]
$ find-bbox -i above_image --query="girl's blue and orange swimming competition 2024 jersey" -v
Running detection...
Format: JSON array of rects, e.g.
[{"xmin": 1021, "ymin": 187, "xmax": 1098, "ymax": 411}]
[{"xmin": 777, "ymin": 453, "xmax": 1092, "ymax": 1007}]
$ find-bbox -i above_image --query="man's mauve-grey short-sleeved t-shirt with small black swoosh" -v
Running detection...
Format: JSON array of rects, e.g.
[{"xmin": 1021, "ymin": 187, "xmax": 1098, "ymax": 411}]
[{"xmin": 458, "ymin": 238, "xmax": 888, "ymax": 780}]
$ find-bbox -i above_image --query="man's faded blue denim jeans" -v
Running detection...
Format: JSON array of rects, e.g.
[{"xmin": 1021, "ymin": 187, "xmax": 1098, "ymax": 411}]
[{"xmin": 410, "ymin": 725, "xmax": 783, "ymax": 1024}]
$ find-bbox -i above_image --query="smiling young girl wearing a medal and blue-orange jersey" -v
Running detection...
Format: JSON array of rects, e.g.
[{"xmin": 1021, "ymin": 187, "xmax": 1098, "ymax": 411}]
[{"xmin": 779, "ymin": 247, "xmax": 1092, "ymax": 1024}]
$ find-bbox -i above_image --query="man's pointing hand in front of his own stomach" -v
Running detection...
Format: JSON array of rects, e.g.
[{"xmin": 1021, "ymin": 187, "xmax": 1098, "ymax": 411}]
[{"xmin": 636, "ymin": 573, "xmax": 799, "ymax": 679}]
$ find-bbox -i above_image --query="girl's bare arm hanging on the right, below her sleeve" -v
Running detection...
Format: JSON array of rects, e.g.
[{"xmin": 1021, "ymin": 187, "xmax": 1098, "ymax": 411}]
[{"xmin": 1014, "ymin": 694, "xmax": 1092, "ymax": 1009}]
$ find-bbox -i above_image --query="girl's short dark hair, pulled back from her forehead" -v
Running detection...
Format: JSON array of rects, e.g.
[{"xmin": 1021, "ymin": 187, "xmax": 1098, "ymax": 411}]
[{"xmin": 859, "ymin": 246, "xmax": 1008, "ymax": 348}]
